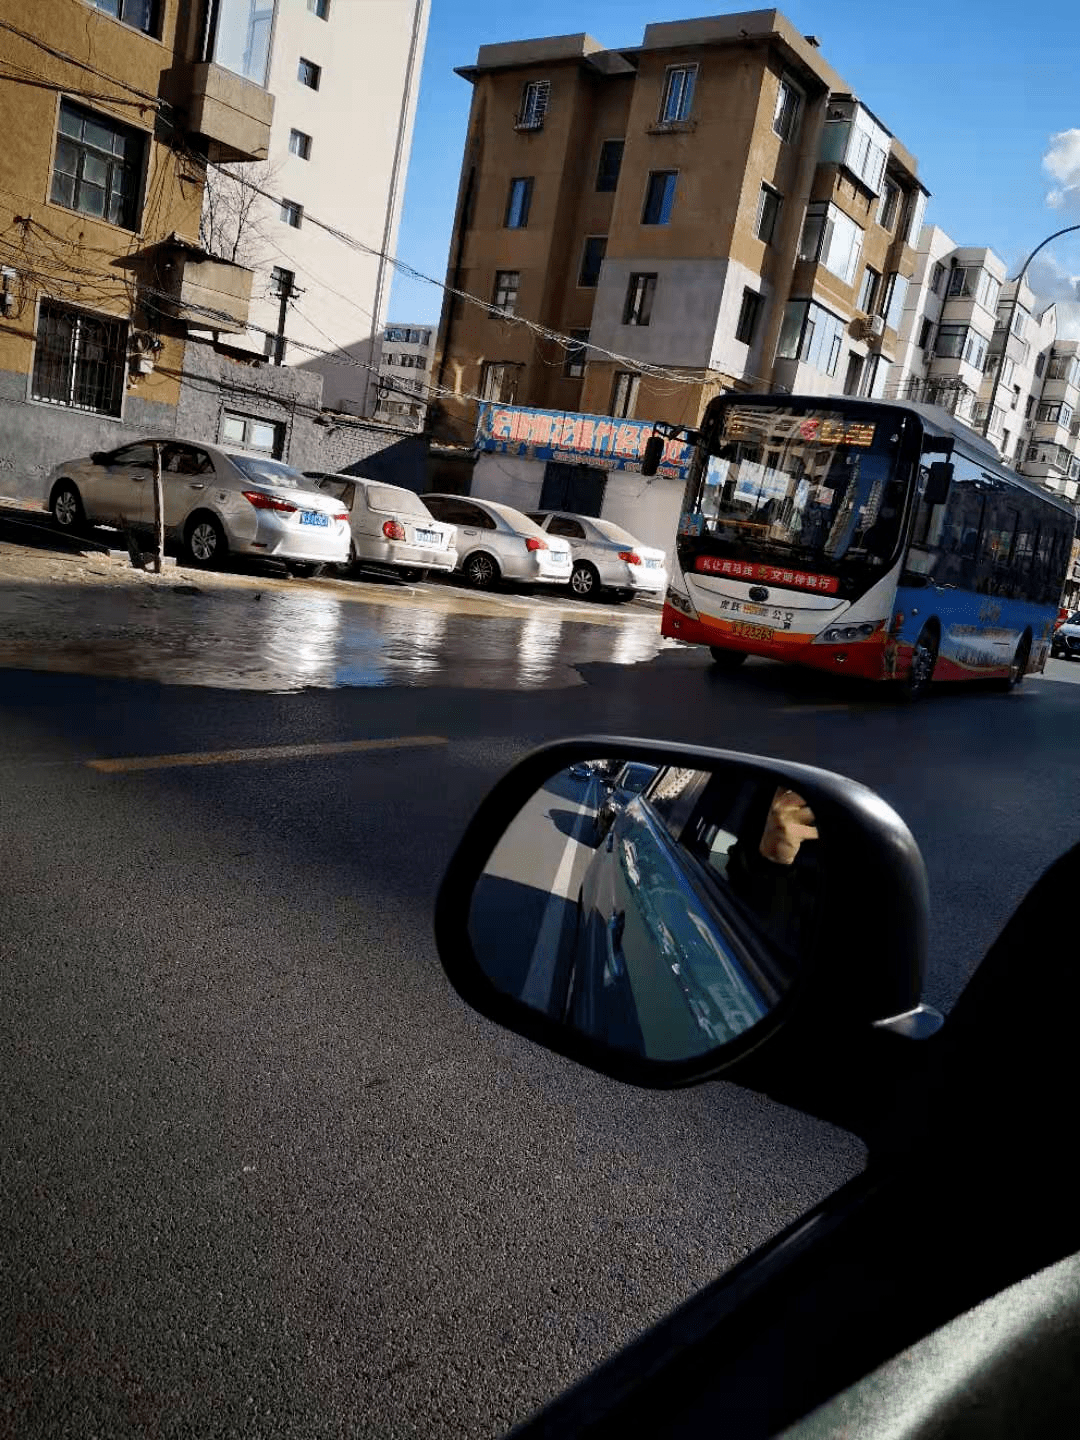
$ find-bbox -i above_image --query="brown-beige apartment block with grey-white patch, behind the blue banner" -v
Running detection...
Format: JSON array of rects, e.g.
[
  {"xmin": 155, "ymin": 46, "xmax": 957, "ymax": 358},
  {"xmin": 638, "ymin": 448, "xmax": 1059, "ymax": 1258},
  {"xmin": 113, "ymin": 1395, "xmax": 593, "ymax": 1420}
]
[{"xmin": 431, "ymin": 10, "xmax": 926, "ymax": 444}]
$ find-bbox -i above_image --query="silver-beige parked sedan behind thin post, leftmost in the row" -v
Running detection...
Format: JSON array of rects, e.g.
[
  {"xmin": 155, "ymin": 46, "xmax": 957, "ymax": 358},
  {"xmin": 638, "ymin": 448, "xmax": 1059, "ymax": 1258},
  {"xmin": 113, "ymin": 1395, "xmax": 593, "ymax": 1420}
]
[{"xmin": 49, "ymin": 438, "xmax": 348, "ymax": 575}]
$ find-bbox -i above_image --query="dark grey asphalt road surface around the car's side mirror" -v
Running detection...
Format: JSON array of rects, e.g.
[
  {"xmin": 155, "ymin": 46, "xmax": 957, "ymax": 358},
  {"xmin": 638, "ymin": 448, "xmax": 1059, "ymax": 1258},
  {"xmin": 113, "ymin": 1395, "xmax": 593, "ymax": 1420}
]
[{"xmin": 0, "ymin": 653, "xmax": 1080, "ymax": 1440}]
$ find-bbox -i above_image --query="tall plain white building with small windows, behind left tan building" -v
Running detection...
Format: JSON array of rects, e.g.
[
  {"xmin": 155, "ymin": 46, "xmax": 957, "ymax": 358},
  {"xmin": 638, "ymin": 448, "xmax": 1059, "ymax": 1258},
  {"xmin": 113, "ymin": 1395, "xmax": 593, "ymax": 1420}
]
[{"xmin": 207, "ymin": 0, "xmax": 431, "ymax": 415}]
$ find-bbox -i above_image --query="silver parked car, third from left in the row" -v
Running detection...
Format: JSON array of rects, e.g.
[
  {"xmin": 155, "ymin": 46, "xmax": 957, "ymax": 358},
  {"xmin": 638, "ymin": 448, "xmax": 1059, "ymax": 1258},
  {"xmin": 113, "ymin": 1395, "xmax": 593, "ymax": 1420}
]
[{"xmin": 423, "ymin": 494, "xmax": 572, "ymax": 590}]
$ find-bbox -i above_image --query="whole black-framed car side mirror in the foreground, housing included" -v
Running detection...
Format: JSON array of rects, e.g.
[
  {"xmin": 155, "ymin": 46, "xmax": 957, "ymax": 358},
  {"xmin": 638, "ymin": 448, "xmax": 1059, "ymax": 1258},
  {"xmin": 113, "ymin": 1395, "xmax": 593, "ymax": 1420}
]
[{"xmin": 435, "ymin": 737, "xmax": 940, "ymax": 1103}]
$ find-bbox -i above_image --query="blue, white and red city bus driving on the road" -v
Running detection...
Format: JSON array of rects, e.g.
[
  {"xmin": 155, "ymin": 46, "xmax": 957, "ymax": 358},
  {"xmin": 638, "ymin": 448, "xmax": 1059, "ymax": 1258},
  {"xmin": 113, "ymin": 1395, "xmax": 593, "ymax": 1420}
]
[{"xmin": 656, "ymin": 395, "xmax": 1076, "ymax": 696}]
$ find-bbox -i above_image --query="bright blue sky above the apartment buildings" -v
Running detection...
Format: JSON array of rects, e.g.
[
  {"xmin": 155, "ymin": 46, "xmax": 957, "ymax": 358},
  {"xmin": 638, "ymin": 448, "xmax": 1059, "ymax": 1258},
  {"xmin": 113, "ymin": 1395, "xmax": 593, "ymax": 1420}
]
[{"xmin": 390, "ymin": 0, "xmax": 1080, "ymax": 336}]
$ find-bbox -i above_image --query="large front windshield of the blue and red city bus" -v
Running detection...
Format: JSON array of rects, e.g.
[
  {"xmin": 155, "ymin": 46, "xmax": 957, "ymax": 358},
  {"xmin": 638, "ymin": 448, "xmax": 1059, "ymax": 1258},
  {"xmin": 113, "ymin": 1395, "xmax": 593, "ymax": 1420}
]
[{"xmin": 694, "ymin": 403, "xmax": 907, "ymax": 573}]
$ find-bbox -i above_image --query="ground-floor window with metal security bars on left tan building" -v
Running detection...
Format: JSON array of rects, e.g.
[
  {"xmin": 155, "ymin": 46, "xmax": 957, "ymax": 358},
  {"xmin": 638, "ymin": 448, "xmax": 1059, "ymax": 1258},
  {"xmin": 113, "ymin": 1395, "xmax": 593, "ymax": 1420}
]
[{"xmin": 30, "ymin": 300, "xmax": 127, "ymax": 415}]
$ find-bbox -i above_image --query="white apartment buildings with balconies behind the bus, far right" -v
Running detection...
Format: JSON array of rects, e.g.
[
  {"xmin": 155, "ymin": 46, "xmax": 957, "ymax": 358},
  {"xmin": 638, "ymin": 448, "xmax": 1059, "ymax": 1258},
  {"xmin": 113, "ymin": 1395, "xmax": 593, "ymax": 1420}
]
[{"xmin": 887, "ymin": 226, "xmax": 1080, "ymax": 500}]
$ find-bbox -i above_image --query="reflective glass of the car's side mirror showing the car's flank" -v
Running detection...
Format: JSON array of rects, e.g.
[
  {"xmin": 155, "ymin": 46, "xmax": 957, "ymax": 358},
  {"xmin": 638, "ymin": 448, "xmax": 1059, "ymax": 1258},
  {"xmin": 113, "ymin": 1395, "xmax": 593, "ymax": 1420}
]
[{"xmin": 469, "ymin": 756, "xmax": 828, "ymax": 1061}]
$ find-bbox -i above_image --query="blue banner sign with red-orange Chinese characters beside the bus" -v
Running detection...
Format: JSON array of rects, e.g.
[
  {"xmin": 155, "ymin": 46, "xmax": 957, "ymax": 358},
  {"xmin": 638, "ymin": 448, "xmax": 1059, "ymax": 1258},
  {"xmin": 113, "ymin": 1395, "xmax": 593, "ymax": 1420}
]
[{"xmin": 477, "ymin": 402, "xmax": 694, "ymax": 481}]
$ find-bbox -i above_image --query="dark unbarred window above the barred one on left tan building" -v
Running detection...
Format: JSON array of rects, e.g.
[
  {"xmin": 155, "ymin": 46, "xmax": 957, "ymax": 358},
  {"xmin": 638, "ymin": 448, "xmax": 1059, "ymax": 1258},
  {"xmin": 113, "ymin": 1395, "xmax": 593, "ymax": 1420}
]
[{"xmin": 49, "ymin": 99, "xmax": 145, "ymax": 230}]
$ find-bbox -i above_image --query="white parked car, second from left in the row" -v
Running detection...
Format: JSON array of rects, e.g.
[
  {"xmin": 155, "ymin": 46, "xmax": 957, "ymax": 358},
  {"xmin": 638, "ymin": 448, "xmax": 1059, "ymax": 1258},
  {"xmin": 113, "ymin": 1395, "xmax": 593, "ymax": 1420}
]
[{"xmin": 308, "ymin": 472, "xmax": 458, "ymax": 579}]
